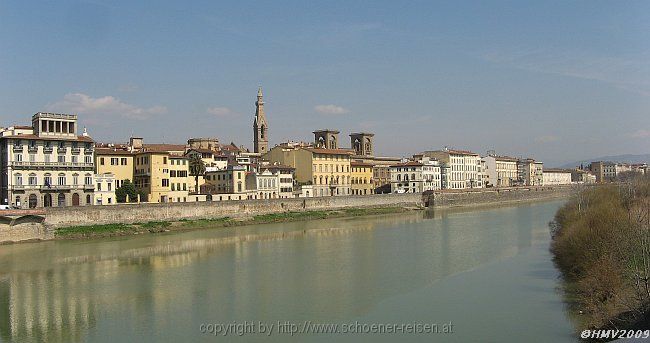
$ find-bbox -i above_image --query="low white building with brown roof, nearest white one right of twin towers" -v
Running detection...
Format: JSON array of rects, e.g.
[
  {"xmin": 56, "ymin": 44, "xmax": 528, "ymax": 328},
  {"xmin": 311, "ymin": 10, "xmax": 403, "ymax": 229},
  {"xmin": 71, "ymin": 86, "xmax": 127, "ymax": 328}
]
[{"xmin": 390, "ymin": 157, "xmax": 442, "ymax": 193}]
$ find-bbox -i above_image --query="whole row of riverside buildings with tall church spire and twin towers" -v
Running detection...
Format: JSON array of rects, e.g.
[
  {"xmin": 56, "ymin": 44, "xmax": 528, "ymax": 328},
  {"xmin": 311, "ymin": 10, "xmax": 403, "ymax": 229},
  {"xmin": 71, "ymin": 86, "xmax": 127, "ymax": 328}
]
[{"xmin": 0, "ymin": 88, "xmax": 647, "ymax": 208}]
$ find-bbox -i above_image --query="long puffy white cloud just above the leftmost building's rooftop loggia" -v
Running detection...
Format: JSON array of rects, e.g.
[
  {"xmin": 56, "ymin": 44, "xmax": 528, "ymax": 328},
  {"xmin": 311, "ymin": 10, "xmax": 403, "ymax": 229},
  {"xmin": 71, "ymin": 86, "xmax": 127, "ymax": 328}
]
[{"xmin": 46, "ymin": 93, "xmax": 167, "ymax": 120}]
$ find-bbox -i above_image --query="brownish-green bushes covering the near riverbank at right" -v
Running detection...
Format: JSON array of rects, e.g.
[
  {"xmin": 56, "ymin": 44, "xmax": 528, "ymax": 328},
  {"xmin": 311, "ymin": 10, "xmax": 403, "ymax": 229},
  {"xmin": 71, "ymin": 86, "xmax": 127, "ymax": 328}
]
[{"xmin": 551, "ymin": 177, "xmax": 650, "ymax": 336}]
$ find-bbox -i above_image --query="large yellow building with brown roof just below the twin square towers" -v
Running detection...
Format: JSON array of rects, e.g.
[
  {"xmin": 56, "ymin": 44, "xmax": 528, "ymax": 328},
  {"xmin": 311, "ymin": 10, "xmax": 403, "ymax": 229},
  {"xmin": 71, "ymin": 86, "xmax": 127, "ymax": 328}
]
[{"xmin": 264, "ymin": 144, "xmax": 352, "ymax": 196}]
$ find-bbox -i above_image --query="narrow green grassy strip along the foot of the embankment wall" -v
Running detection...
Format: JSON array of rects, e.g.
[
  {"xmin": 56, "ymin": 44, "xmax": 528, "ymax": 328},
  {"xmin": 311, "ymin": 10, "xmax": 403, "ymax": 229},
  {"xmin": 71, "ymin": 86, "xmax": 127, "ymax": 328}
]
[{"xmin": 54, "ymin": 207, "xmax": 410, "ymax": 239}]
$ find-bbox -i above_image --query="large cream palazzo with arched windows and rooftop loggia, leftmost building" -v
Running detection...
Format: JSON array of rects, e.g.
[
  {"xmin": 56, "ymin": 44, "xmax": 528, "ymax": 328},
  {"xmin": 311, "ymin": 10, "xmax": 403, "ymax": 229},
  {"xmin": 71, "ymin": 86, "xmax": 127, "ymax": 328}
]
[{"xmin": 0, "ymin": 112, "xmax": 95, "ymax": 208}]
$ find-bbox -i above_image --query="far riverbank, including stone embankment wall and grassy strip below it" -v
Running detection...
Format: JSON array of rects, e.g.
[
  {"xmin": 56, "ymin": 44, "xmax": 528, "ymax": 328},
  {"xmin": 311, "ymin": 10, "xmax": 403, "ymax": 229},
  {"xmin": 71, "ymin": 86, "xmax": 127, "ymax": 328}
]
[{"xmin": 0, "ymin": 186, "xmax": 576, "ymax": 243}]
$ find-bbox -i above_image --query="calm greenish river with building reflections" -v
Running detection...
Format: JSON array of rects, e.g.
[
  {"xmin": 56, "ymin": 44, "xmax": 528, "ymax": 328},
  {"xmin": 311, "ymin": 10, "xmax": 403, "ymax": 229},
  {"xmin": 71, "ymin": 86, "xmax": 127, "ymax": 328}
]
[{"xmin": 0, "ymin": 201, "xmax": 576, "ymax": 342}]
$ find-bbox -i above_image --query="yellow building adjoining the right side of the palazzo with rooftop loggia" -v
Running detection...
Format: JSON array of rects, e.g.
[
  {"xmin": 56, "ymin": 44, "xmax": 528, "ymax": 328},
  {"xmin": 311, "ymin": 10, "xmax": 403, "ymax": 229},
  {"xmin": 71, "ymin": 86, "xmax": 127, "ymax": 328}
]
[{"xmin": 95, "ymin": 148, "xmax": 135, "ymax": 188}]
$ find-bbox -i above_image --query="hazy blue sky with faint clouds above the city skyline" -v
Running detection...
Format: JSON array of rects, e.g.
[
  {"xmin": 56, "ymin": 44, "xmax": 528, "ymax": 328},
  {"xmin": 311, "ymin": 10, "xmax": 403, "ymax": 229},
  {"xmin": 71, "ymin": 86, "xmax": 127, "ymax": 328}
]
[{"xmin": 0, "ymin": 0, "xmax": 650, "ymax": 165}]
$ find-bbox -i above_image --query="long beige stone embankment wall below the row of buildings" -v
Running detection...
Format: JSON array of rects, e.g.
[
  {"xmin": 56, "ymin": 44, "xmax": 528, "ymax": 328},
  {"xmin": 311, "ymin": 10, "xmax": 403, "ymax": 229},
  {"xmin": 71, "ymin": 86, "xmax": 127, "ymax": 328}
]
[{"xmin": 0, "ymin": 186, "xmax": 575, "ymax": 242}]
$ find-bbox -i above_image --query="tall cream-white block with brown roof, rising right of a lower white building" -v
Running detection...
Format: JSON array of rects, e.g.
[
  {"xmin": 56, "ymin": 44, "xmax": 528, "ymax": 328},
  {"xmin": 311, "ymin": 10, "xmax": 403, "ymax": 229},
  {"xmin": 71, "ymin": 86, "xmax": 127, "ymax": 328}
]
[{"xmin": 422, "ymin": 149, "xmax": 484, "ymax": 189}]
